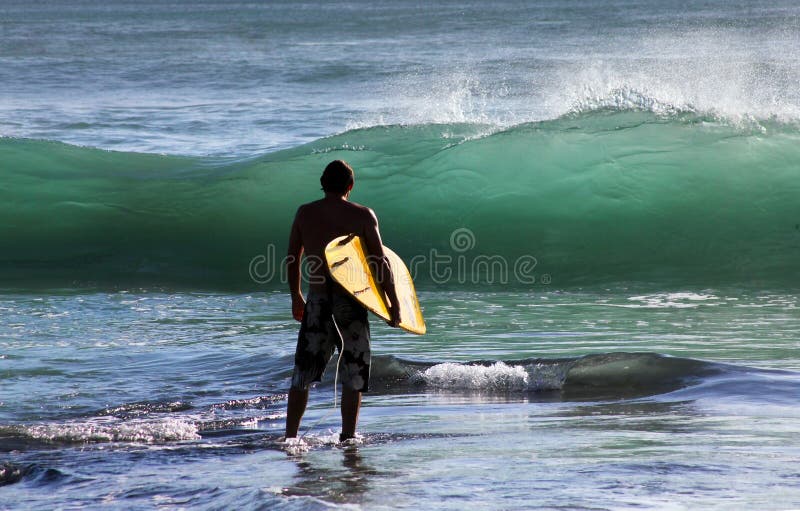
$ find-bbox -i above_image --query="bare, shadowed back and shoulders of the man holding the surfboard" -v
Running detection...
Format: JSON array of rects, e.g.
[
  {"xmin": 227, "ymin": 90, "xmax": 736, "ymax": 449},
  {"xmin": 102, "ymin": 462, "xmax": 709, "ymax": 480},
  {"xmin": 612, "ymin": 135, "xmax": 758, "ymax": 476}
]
[{"xmin": 289, "ymin": 197, "xmax": 383, "ymax": 291}]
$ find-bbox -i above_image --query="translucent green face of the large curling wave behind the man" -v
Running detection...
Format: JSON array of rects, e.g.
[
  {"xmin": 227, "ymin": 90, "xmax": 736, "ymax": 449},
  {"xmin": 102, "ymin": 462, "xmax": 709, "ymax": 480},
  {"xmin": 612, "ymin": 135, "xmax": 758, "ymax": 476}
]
[{"xmin": 0, "ymin": 111, "xmax": 800, "ymax": 289}]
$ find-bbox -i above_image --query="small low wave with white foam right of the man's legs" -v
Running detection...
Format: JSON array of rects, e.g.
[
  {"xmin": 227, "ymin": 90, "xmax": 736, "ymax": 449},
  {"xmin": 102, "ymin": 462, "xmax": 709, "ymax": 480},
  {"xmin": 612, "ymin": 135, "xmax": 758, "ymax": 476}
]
[{"xmin": 372, "ymin": 352, "xmax": 800, "ymax": 406}]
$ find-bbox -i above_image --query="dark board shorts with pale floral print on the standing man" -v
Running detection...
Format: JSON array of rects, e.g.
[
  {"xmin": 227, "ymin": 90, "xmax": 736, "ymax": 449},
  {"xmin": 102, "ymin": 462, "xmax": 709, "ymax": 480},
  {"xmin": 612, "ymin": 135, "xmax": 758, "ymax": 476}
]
[{"xmin": 292, "ymin": 286, "xmax": 371, "ymax": 392}]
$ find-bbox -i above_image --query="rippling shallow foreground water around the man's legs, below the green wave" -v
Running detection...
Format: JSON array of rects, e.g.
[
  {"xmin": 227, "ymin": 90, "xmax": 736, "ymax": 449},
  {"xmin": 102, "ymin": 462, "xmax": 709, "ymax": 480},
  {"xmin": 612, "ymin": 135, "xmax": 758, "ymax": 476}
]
[{"xmin": 0, "ymin": 289, "xmax": 800, "ymax": 509}]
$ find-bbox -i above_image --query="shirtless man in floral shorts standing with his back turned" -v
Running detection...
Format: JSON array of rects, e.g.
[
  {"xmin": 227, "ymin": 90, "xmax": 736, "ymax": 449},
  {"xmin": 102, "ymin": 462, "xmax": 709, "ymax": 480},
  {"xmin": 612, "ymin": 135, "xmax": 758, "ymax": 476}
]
[{"xmin": 286, "ymin": 160, "xmax": 400, "ymax": 442}]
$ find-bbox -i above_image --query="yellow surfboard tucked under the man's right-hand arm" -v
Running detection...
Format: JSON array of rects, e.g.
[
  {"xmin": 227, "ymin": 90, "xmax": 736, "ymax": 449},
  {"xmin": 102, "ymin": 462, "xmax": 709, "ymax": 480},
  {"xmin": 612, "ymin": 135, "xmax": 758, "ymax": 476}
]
[{"xmin": 325, "ymin": 234, "xmax": 426, "ymax": 335}]
